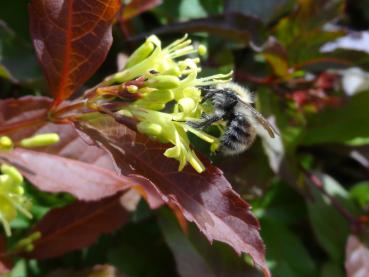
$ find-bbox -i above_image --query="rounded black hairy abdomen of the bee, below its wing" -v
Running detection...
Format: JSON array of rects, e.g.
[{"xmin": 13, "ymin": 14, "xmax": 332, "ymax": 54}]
[{"xmin": 220, "ymin": 115, "xmax": 255, "ymax": 155}]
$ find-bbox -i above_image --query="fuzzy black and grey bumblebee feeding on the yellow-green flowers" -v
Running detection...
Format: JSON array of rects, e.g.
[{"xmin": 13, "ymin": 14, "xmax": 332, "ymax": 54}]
[{"xmin": 187, "ymin": 82, "xmax": 278, "ymax": 155}]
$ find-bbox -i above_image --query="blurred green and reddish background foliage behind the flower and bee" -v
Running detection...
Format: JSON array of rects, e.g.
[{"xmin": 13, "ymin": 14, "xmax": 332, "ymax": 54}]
[{"xmin": 0, "ymin": 0, "xmax": 369, "ymax": 277}]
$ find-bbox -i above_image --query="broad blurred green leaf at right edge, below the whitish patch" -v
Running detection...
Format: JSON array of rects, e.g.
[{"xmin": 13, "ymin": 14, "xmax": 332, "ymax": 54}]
[{"xmin": 301, "ymin": 92, "xmax": 369, "ymax": 145}]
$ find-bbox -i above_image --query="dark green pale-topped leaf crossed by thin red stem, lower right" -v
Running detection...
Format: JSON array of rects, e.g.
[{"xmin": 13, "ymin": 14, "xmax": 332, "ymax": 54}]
[{"xmin": 307, "ymin": 175, "xmax": 352, "ymax": 263}]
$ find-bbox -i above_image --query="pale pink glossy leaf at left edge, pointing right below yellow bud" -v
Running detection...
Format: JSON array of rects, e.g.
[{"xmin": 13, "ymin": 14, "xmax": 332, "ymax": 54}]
[{"xmin": 0, "ymin": 148, "xmax": 139, "ymax": 201}]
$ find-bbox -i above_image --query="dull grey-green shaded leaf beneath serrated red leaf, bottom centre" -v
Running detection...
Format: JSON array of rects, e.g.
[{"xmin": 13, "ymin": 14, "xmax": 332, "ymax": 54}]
[{"xmin": 158, "ymin": 208, "xmax": 259, "ymax": 277}]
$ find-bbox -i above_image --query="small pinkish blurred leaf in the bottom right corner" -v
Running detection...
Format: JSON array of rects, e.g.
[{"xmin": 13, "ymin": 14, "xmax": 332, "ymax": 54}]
[{"xmin": 345, "ymin": 235, "xmax": 369, "ymax": 277}]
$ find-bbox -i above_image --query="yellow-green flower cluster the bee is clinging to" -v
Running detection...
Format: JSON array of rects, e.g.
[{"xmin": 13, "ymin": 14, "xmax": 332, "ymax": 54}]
[{"xmin": 95, "ymin": 35, "xmax": 232, "ymax": 173}]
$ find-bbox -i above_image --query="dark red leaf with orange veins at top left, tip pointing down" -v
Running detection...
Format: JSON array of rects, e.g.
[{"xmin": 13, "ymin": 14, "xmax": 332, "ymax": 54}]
[{"xmin": 29, "ymin": 0, "xmax": 120, "ymax": 104}]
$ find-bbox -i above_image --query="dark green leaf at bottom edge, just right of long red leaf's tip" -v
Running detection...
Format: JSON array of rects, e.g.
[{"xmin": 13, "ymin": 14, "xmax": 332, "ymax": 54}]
[{"xmin": 260, "ymin": 218, "xmax": 316, "ymax": 277}]
